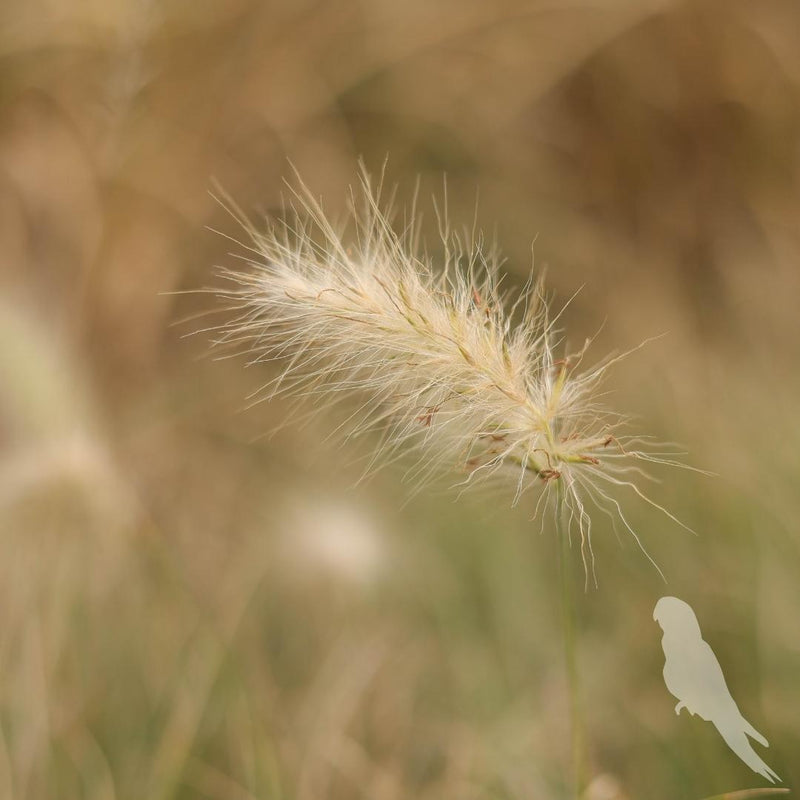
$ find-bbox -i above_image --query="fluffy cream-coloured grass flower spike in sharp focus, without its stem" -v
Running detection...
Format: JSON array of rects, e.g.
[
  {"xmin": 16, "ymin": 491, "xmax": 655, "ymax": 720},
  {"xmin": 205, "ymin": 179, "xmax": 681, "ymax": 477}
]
[{"xmin": 214, "ymin": 167, "xmax": 692, "ymax": 574}]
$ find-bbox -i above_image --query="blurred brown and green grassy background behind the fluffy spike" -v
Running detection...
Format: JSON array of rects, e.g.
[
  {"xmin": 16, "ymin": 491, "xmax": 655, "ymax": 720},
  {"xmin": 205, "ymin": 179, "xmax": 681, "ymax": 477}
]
[{"xmin": 0, "ymin": 0, "xmax": 800, "ymax": 800}]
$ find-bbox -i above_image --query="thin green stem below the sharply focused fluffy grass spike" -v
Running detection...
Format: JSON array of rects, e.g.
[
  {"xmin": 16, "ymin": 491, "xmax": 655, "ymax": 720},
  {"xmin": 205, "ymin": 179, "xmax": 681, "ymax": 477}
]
[{"xmin": 556, "ymin": 488, "xmax": 586, "ymax": 800}]
